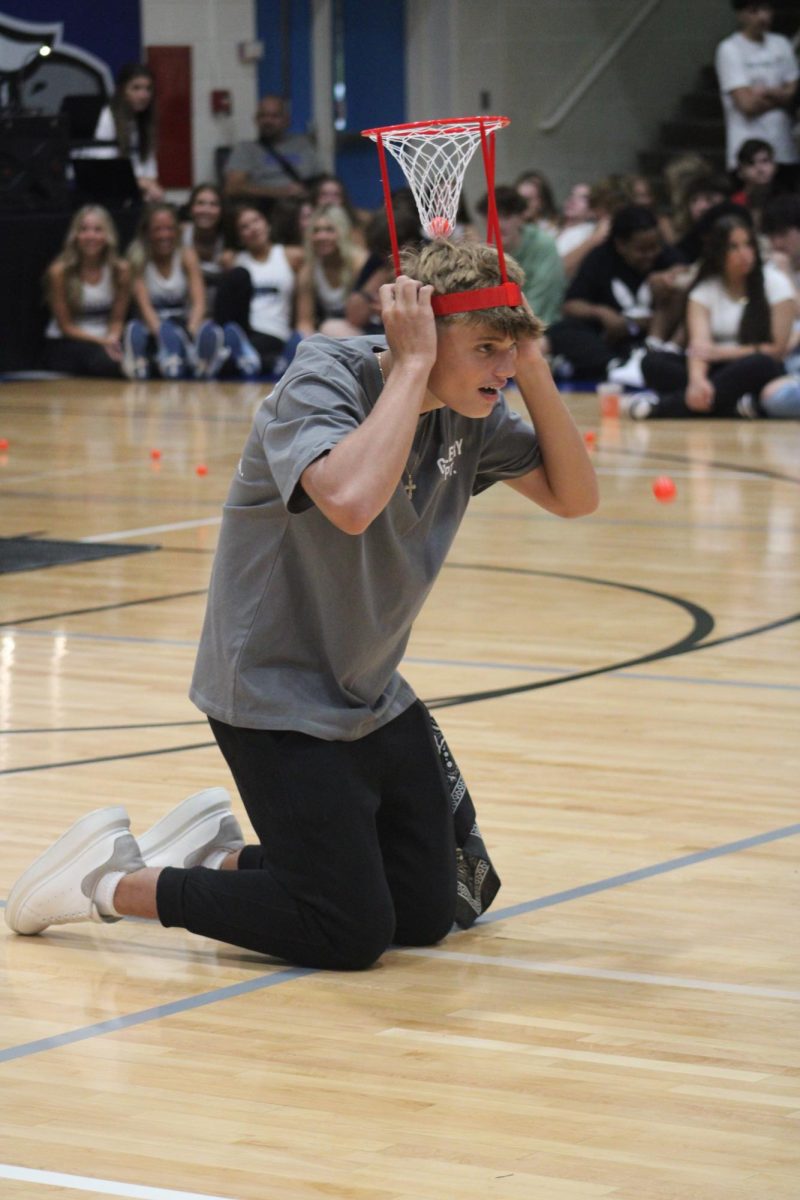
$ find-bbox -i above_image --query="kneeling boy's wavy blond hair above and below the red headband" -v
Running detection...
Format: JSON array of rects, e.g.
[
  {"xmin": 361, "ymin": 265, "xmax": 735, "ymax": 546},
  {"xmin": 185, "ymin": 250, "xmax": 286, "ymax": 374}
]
[{"xmin": 401, "ymin": 239, "xmax": 545, "ymax": 338}]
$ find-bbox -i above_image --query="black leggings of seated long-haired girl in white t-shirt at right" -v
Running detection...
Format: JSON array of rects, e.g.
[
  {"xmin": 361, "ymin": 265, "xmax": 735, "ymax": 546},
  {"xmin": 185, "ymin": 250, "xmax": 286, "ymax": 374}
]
[{"xmin": 642, "ymin": 350, "xmax": 783, "ymax": 419}]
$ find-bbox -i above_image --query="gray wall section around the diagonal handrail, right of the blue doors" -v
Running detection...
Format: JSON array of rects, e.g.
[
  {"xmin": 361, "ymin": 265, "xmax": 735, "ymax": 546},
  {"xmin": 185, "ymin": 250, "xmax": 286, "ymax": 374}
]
[{"xmin": 407, "ymin": 0, "xmax": 735, "ymax": 200}]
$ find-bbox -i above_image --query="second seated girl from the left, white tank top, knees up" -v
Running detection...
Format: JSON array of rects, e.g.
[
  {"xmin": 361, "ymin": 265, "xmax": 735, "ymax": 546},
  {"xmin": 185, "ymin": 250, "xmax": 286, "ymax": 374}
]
[{"xmin": 124, "ymin": 203, "xmax": 222, "ymax": 379}]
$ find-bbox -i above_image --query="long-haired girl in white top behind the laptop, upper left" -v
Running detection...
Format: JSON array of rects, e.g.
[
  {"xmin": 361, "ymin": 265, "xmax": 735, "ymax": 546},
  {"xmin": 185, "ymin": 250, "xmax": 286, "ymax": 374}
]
[{"xmin": 76, "ymin": 62, "xmax": 164, "ymax": 204}]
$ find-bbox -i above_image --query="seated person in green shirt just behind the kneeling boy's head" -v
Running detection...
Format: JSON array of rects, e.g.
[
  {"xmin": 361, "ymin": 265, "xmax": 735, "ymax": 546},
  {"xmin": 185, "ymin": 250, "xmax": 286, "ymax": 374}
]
[{"xmin": 477, "ymin": 186, "xmax": 566, "ymax": 325}]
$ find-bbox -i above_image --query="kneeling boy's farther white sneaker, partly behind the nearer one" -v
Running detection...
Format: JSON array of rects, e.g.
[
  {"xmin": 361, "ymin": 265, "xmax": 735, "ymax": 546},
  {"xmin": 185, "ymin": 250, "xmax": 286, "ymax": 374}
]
[{"xmin": 139, "ymin": 787, "xmax": 245, "ymax": 869}]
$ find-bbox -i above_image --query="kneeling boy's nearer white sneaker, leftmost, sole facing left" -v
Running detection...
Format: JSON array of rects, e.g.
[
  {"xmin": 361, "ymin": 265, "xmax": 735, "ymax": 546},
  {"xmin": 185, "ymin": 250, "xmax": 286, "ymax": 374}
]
[{"xmin": 6, "ymin": 808, "xmax": 145, "ymax": 934}]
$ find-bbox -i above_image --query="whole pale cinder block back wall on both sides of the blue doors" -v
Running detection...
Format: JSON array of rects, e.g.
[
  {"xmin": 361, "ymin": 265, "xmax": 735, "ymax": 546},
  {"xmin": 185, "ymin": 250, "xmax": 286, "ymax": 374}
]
[{"xmin": 142, "ymin": 0, "xmax": 735, "ymax": 202}]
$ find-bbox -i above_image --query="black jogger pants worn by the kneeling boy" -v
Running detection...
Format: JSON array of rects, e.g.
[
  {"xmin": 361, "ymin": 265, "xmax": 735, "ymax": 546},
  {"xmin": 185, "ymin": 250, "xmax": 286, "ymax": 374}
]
[{"xmin": 157, "ymin": 701, "xmax": 456, "ymax": 970}]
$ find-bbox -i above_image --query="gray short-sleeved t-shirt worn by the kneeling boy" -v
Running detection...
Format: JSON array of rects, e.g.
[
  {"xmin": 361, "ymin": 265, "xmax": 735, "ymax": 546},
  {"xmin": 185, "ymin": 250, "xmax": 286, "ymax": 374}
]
[{"xmin": 190, "ymin": 335, "xmax": 541, "ymax": 742}]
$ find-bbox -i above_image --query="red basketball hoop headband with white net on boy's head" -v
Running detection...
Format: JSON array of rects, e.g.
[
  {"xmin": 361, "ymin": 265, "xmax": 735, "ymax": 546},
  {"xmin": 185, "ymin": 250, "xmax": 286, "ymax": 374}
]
[{"xmin": 361, "ymin": 116, "xmax": 522, "ymax": 317}]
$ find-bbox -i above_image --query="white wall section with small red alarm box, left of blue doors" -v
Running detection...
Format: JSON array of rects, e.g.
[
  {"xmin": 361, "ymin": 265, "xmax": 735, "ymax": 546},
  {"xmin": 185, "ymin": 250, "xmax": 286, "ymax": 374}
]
[{"xmin": 142, "ymin": 0, "xmax": 258, "ymax": 199}]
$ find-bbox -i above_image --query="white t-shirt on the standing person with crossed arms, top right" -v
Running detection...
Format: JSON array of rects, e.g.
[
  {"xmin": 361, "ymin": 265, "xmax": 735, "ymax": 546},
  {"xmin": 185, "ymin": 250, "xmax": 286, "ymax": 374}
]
[{"xmin": 715, "ymin": 34, "xmax": 800, "ymax": 168}]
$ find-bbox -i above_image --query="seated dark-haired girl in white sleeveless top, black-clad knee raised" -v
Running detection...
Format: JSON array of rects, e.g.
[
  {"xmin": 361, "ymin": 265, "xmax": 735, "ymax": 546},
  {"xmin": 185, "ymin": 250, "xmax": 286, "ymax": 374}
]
[{"xmin": 215, "ymin": 204, "xmax": 305, "ymax": 379}]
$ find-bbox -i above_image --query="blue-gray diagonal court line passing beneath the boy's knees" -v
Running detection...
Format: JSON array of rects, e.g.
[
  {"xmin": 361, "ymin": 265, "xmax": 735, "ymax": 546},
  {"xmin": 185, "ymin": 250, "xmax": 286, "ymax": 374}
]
[{"xmin": 0, "ymin": 823, "xmax": 800, "ymax": 1062}]
